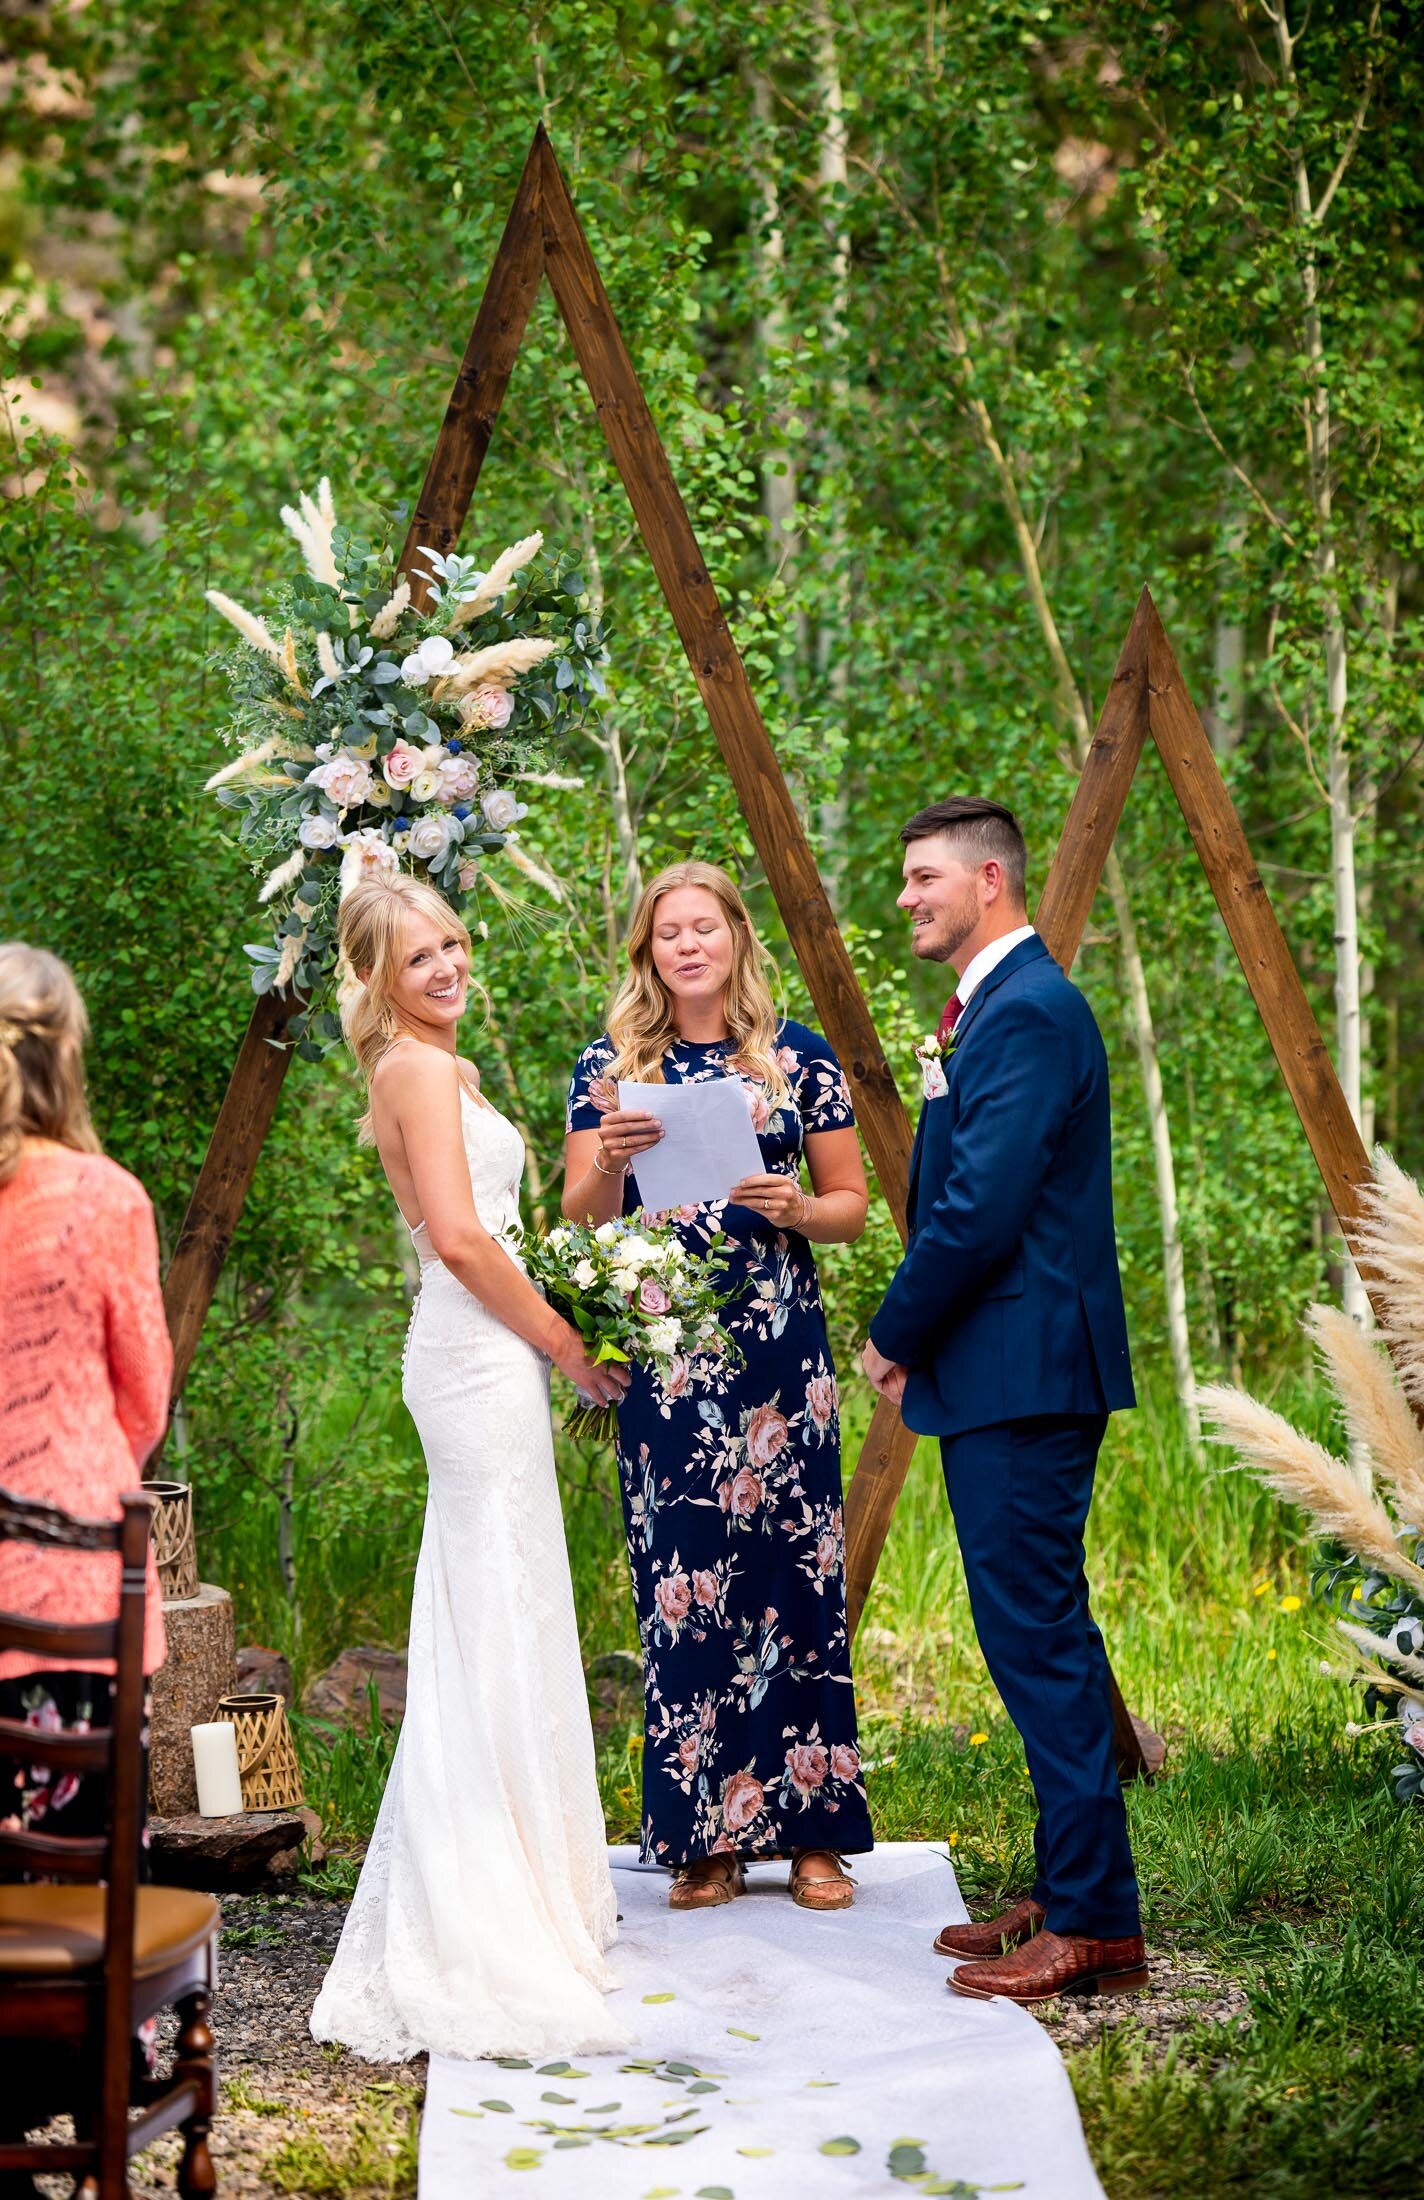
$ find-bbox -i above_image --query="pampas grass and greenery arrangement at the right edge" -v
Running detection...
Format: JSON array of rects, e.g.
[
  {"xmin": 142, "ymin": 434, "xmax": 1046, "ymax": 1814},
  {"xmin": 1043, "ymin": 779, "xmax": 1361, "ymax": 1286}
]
[{"xmin": 1197, "ymin": 1146, "xmax": 1424, "ymax": 1802}]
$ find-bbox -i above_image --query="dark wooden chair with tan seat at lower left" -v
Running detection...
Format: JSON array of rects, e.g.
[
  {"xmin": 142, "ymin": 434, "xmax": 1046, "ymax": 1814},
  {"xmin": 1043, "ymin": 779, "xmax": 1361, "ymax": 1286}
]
[{"xmin": 0, "ymin": 1489, "xmax": 220, "ymax": 2200}]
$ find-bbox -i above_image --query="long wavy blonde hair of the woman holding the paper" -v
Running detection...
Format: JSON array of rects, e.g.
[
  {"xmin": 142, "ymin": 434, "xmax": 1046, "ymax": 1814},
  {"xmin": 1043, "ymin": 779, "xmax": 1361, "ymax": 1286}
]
[{"xmin": 605, "ymin": 862, "xmax": 790, "ymax": 1100}]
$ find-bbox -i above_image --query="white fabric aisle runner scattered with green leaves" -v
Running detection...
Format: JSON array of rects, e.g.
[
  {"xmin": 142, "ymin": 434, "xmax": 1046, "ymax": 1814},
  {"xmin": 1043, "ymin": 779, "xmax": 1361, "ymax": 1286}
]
[{"xmin": 420, "ymin": 1841, "xmax": 1103, "ymax": 2200}]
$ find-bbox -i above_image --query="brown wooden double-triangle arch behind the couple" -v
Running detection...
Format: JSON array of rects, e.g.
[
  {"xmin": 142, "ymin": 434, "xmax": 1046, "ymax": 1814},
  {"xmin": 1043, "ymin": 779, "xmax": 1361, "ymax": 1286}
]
[{"xmin": 165, "ymin": 125, "xmax": 1369, "ymax": 1773}]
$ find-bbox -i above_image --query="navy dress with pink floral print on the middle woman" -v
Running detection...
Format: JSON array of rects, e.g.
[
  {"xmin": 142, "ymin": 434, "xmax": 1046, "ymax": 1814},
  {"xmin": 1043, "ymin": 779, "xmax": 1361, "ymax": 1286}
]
[{"xmin": 568, "ymin": 1023, "xmax": 872, "ymax": 1866}]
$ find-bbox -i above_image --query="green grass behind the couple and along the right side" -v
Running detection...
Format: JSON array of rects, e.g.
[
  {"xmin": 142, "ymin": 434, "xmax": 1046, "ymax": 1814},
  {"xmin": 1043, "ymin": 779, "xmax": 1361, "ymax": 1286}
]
[{"xmin": 213, "ymin": 1397, "xmax": 1424, "ymax": 2200}]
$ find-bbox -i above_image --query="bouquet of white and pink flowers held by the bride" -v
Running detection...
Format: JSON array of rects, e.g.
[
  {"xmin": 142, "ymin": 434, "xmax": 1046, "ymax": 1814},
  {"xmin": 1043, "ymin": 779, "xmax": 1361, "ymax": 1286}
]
[{"xmin": 517, "ymin": 1214, "xmax": 737, "ymax": 1437}]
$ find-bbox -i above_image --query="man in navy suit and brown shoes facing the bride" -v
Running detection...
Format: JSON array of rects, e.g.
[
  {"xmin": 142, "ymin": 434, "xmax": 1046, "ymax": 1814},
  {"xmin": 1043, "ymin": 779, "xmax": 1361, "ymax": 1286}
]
[{"xmin": 863, "ymin": 796, "xmax": 1147, "ymax": 2002}]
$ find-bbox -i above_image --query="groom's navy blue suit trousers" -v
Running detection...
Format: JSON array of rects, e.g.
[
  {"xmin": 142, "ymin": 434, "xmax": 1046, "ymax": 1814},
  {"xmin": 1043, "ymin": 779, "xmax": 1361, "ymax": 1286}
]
[{"xmin": 940, "ymin": 1415, "xmax": 1142, "ymax": 1938}]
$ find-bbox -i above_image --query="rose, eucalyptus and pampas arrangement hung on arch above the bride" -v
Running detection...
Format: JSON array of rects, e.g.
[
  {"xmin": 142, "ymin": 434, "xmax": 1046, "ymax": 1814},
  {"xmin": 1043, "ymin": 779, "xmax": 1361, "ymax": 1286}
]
[{"xmin": 207, "ymin": 482, "xmax": 607, "ymax": 1058}]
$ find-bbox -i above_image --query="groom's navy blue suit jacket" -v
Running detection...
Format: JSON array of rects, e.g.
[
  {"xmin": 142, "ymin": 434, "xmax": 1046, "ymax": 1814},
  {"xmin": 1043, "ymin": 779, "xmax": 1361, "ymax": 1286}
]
[{"xmin": 869, "ymin": 937, "xmax": 1136, "ymax": 1437}]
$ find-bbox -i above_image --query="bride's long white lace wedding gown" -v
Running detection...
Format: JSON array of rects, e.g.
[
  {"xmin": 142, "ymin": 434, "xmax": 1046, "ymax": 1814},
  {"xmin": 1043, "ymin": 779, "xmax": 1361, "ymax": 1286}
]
[{"xmin": 310, "ymin": 1091, "xmax": 629, "ymax": 2061}]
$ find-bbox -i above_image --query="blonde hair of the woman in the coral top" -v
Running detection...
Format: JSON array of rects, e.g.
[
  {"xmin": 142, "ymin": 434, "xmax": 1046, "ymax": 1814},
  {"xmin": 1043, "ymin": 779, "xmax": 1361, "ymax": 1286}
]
[{"xmin": 0, "ymin": 939, "xmax": 101, "ymax": 1184}]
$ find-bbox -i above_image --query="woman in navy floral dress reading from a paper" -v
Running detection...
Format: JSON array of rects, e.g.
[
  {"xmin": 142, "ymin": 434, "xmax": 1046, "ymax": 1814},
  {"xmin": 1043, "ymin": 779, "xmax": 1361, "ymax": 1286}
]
[{"xmin": 563, "ymin": 862, "xmax": 872, "ymax": 1910}]
